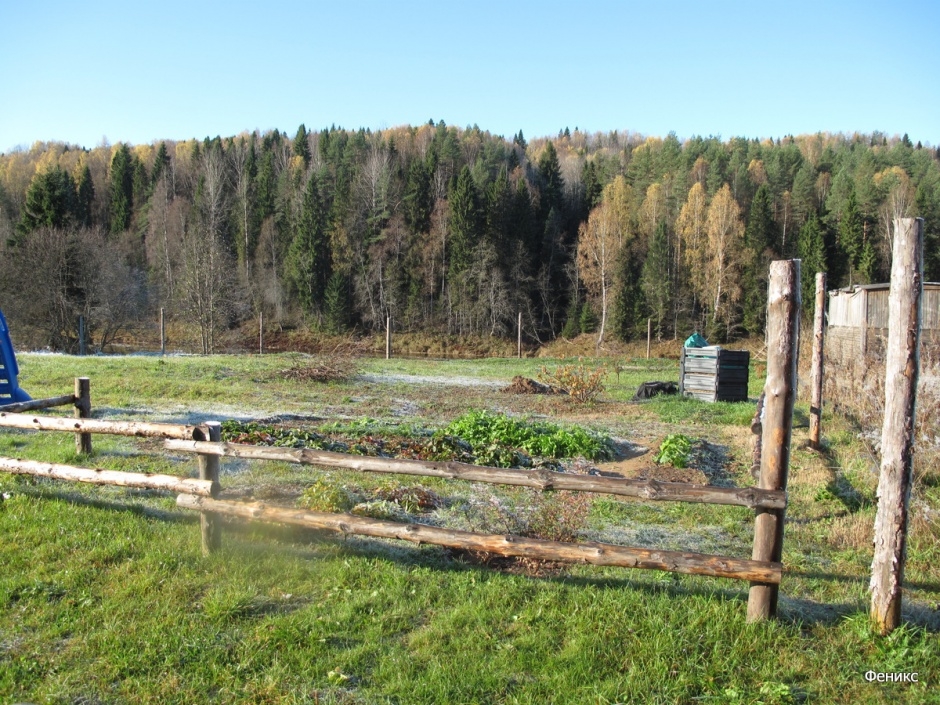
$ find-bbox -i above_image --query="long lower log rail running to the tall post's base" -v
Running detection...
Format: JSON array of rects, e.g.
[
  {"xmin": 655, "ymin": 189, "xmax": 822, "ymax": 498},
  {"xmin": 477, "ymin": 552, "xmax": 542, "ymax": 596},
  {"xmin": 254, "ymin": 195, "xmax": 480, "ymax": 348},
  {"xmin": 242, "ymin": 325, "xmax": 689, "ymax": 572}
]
[{"xmin": 176, "ymin": 495, "xmax": 783, "ymax": 584}]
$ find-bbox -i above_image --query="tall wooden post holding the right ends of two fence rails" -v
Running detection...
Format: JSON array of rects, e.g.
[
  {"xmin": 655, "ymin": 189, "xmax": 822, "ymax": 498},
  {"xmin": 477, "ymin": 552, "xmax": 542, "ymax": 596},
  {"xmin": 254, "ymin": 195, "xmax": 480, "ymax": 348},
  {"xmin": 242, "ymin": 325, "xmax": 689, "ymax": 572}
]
[{"xmin": 747, "ymin": 260, "xmax": 801, "ymax": 622}]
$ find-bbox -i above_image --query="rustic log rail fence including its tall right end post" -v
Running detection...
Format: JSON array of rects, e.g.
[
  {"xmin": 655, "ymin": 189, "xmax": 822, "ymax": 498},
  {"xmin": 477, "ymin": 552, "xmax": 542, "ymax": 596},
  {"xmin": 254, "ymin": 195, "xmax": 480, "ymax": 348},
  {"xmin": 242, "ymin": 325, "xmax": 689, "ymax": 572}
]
[{"xmin": 0, "ymin": 260, "xmax": 800, "ymax": 621}]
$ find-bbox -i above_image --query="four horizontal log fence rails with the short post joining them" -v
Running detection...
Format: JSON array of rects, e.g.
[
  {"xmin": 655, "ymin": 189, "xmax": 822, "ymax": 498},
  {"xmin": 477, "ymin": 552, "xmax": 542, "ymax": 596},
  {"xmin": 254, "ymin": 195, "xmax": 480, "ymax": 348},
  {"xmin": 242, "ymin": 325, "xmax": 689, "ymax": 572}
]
[{"xmin": 0, "ymin": 404, "xmax": 786, "ymax": 585}]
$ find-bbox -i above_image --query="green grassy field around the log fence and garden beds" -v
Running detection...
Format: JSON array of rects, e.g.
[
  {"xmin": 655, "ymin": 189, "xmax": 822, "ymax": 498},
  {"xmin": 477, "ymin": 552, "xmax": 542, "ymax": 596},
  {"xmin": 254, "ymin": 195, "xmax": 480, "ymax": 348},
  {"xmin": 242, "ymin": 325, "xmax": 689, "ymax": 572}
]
[{"xmin": 0, "ymin": 354, "xmax": 940, "ymax": 705}]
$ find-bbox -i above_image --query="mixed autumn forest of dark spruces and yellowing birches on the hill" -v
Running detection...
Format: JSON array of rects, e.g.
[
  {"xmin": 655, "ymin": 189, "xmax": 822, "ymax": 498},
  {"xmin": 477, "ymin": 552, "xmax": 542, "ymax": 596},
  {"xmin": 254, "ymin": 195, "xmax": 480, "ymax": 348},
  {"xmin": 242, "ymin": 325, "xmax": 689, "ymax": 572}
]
[{"xmin": 0, "ymin": 120, "xmax": 940, "ymax": 353}]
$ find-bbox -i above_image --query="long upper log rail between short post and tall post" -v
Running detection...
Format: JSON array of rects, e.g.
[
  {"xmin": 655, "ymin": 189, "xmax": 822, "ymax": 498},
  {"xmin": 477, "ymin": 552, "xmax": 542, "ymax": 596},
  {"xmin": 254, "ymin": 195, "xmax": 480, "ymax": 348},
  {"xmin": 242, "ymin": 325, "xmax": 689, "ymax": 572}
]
[{"xmin": 164, "ymin": 440, "xmax": 787, "ymax": 509}]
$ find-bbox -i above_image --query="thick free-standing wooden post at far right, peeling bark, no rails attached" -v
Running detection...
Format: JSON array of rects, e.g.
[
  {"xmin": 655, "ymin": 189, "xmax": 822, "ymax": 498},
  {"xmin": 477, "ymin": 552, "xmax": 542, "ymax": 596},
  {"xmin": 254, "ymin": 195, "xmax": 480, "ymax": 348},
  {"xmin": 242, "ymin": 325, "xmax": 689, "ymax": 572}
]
[{"xmin": 871, "ymin": 218, "xmax": 924, "ymax": 634}]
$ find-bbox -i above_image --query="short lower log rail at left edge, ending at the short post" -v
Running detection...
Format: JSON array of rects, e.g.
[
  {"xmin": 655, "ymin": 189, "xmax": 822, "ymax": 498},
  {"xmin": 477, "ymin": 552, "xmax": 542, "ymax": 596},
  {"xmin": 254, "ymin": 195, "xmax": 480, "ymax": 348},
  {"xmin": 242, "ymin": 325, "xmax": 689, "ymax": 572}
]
[{"xmin": 0, "ymin": 458, "xmax": 218, "ymax": 497}]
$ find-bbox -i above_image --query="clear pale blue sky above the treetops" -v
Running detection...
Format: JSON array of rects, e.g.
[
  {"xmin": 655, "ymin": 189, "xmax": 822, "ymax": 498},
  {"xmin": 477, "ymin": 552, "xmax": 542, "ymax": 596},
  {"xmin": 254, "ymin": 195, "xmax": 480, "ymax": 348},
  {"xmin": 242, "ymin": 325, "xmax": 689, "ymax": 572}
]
[{"xmin": 0, "ymin": 0, "xmax": 940, "ymax": 152}]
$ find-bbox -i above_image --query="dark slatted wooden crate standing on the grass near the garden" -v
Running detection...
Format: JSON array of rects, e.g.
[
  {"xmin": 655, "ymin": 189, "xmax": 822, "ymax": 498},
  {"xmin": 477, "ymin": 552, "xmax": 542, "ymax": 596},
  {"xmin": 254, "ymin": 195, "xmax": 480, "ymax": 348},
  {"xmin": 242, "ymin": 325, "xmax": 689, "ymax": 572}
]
[{"xmin": 679, "ymin": 346, "xmax": 751, "ymax": 401}]
